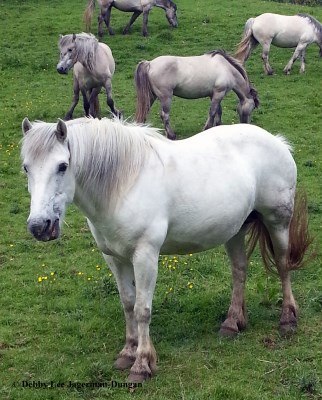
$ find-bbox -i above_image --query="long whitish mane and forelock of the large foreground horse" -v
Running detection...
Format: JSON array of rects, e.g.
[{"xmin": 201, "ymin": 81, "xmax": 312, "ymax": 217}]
[{"xmin": 22, "ymin": 118, "xmax": 168, "ymax": 205}]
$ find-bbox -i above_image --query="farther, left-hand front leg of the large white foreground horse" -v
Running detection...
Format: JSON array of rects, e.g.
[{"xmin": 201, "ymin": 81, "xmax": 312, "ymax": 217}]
[{"xmin": 104, "ymin": 255, "xmax": 138, "ymax": 370}]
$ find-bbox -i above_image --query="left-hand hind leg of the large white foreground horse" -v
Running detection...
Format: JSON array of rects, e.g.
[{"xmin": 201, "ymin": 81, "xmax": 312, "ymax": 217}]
[{"xmin": 219, "ymin": 228, "xmax": 247, "ymax": 336}]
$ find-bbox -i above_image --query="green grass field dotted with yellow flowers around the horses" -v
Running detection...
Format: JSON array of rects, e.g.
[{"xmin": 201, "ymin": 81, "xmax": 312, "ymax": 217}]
[{"xmin": 0, "ymin": 0, "xmax": 322, "ymax": 400}]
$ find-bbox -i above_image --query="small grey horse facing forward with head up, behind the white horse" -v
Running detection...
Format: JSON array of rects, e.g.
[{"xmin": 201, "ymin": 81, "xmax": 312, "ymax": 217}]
[{"xmin": 57, "ymin": 33, "xmax": 120, "ymax": 120}]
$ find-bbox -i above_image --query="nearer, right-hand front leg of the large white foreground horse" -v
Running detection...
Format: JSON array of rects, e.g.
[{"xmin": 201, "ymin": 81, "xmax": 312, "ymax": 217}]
[{"xmin": 128, "ymin": 247, "xmax": 159, "ymax": 382}]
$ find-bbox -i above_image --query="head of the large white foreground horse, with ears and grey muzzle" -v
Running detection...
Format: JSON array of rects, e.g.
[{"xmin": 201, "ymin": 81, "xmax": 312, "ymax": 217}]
[{"xmin": 21, "ymin": 118, "xmax": 75, "ymax": 241}]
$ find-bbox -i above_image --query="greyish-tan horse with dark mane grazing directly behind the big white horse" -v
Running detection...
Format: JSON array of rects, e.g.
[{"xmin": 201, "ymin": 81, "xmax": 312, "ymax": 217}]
[{"xmin": 135, "ymin": 50, "xmax": 259, "ymax": 139}]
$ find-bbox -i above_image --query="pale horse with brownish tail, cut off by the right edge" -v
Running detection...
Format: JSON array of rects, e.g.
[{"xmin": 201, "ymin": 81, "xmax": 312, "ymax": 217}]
[{"xmin": 235, "ymin": 13, "xmax": 322, "ymax": 75}]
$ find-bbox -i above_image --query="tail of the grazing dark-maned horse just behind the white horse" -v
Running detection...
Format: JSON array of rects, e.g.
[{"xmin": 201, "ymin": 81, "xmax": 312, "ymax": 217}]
[{"xmin": 134, "ymin": 61, "xmax": 155, "ymax": 123}]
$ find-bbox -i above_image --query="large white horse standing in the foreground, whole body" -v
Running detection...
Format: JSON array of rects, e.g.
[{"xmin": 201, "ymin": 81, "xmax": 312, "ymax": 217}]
[{"xmin": 21, "ymin": 118, "xmax": 310, "ymax": 382}]
